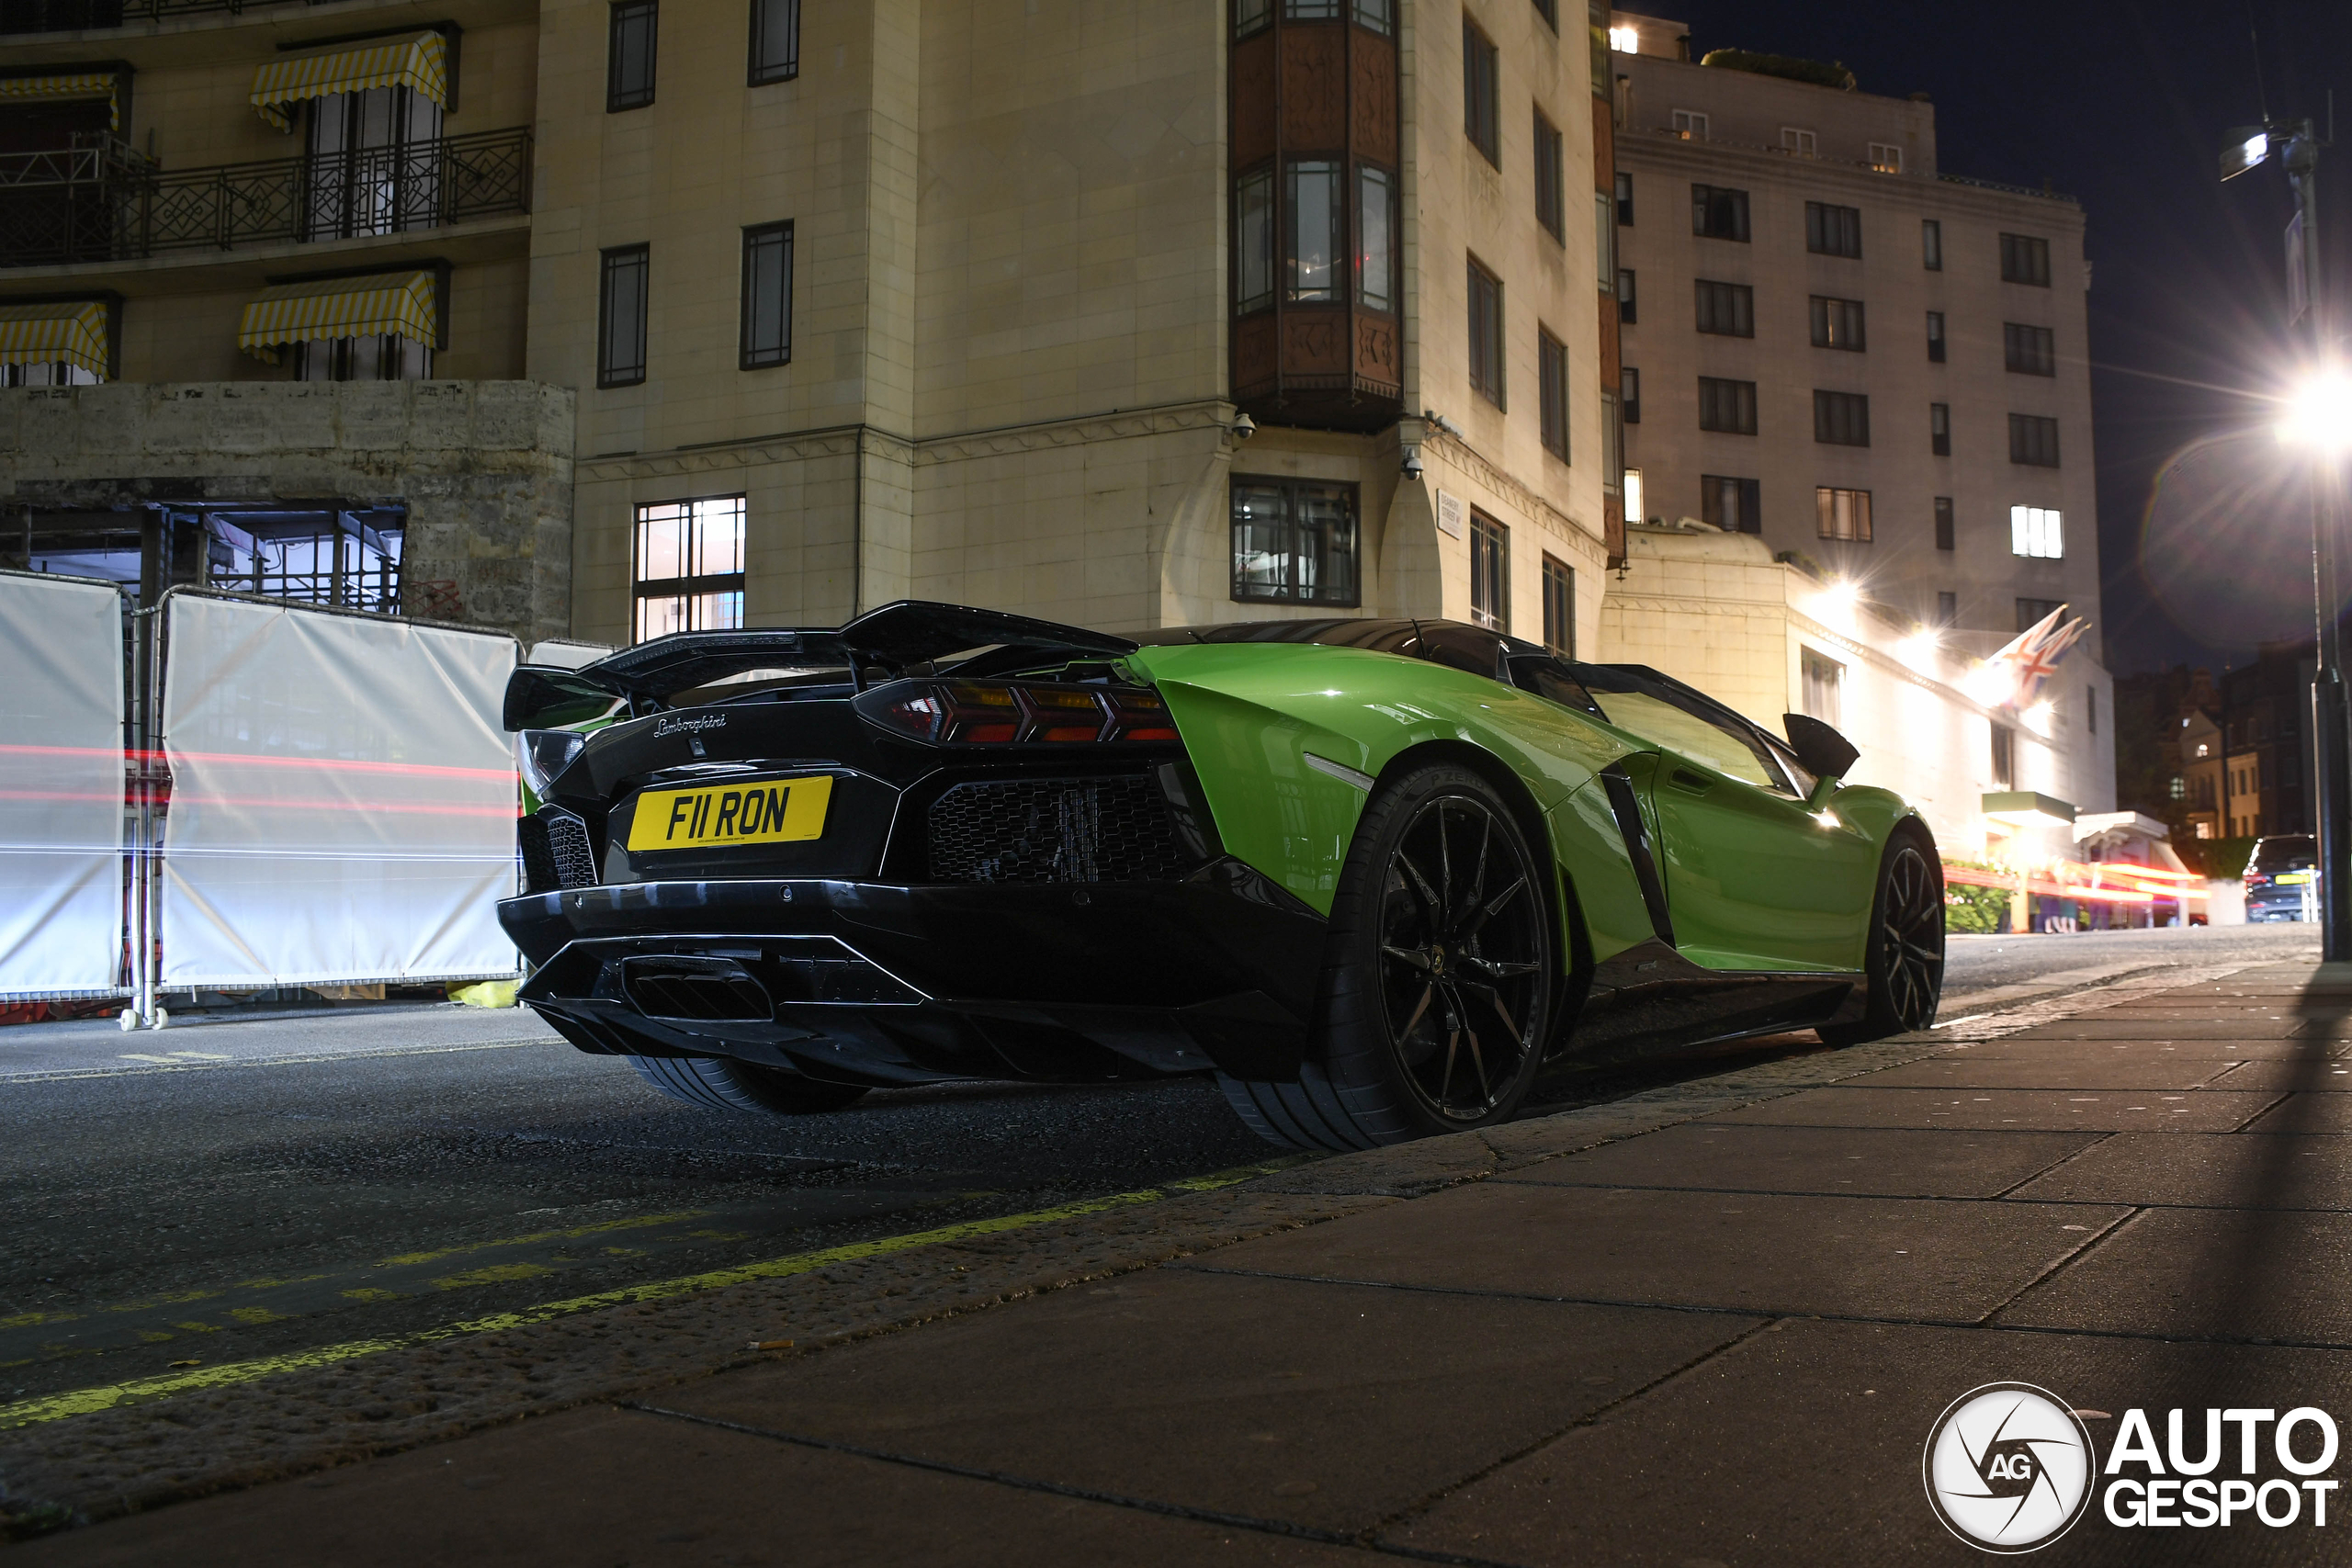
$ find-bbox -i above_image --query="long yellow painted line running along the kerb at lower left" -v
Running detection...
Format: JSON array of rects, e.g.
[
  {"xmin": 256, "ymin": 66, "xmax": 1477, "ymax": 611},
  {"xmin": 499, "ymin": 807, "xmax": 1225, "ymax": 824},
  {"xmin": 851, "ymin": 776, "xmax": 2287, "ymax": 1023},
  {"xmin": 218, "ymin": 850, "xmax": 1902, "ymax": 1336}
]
[{"xmin": 0, "ymin": 1156, "xmax": 1312, "ymax": 1429}]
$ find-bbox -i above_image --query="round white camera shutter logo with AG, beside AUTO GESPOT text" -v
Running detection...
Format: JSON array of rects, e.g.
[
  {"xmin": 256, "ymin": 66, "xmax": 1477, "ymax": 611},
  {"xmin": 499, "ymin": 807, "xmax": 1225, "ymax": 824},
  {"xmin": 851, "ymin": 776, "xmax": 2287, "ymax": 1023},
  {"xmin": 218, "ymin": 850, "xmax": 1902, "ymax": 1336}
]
[{"xmin": 1919, "ymin": 1382, "xmax": 2098, "ymax": 1554}]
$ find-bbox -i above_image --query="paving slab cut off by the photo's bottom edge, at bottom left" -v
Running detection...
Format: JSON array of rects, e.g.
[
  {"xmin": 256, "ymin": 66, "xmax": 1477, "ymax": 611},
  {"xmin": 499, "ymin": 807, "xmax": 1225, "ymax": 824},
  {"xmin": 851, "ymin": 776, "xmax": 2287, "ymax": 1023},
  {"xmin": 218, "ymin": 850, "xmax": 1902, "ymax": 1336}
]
[{"xmin": 12, "ymin": 1408, "xmax": 1364, "ymax": 1568}]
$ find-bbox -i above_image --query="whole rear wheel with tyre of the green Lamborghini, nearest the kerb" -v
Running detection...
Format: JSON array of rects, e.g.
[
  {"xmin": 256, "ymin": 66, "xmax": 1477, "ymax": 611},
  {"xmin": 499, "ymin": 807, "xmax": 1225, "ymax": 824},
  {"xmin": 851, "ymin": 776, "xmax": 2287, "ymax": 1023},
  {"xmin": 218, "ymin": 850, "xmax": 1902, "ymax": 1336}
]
[{"xmin": 1218, "ymin": 764, "xmax": 1557, "ymax": 1149}]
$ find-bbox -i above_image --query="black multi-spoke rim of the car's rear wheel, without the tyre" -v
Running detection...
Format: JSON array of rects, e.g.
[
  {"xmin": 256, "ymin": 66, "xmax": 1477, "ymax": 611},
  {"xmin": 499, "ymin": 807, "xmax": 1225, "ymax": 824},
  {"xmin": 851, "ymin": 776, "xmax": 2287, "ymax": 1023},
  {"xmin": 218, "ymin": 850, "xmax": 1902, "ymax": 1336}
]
[{"xmin": 1381, "ymin": 792, "xmax": 1547, "ymax": 1126}]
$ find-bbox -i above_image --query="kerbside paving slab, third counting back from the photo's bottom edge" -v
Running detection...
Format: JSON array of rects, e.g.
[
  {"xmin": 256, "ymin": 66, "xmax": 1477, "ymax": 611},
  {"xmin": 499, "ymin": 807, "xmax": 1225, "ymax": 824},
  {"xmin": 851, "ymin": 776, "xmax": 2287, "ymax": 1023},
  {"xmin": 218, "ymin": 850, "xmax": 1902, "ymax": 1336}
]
[{"xmin": 1185, "ymin": 1178, "xmax": 2129, "ymax": 1324}]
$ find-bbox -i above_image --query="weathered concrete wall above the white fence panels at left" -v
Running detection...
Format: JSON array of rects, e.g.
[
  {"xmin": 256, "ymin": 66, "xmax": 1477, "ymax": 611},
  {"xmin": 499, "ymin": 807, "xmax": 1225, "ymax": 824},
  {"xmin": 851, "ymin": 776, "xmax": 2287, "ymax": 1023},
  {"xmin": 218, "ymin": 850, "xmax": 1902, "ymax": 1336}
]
[{"xmin": 0, "ymin": 381, "xmax": 574, "ymax": 642}]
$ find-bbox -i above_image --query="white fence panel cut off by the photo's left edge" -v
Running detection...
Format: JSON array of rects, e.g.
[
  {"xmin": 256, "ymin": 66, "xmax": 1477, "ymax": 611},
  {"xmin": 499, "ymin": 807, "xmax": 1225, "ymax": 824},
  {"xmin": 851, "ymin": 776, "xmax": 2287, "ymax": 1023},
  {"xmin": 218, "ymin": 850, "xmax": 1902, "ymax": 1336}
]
[{"xmin": 0, "ymin": 571, "xmax": 122, "ymax": 999}]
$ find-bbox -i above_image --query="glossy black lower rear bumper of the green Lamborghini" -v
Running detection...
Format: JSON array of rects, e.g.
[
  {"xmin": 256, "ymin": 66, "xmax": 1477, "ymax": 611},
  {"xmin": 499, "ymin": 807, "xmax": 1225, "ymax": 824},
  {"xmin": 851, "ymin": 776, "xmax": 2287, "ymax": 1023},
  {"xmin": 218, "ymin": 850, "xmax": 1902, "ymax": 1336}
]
[{"xmin": 499, "ymin": 861, "xmax": 1324, "ymax": 1084}]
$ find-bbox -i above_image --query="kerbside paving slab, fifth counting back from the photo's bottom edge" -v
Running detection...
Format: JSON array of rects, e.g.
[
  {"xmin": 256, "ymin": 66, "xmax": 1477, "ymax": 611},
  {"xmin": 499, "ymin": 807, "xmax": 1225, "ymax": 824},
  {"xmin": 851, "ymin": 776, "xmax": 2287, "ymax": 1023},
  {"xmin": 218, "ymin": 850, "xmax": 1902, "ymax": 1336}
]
[{"xmin": 1714, "ymin": 1086, "xmax": 2281, "ymax": 1134}]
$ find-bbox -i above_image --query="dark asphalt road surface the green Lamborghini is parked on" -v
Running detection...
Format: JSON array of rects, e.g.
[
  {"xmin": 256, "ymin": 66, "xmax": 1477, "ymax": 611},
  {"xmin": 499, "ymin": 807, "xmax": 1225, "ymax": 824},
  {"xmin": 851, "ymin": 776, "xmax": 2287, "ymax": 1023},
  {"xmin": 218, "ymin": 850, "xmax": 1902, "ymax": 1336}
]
[{"xmin": 0, "ymin": 926, "xmax": 2314, "ymax": 1401}]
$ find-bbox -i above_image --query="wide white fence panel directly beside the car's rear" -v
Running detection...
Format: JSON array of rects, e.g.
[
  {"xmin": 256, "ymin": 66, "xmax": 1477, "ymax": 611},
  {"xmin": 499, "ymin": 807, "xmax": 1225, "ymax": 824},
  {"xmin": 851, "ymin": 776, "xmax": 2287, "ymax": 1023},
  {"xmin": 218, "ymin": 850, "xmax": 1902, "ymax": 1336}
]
[{"xmin": 158, "ymin": 592, "xmax": 517, "ymax": 987}]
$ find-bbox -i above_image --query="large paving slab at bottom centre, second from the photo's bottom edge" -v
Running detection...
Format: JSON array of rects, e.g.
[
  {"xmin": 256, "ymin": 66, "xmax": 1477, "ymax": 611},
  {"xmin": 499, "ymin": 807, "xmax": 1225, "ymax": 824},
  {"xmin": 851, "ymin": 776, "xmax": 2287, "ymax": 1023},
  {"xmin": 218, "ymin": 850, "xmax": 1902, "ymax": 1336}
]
[{"xmin": 663, "ymin": 1269, "xmax": 1761, "ymax": 1533}]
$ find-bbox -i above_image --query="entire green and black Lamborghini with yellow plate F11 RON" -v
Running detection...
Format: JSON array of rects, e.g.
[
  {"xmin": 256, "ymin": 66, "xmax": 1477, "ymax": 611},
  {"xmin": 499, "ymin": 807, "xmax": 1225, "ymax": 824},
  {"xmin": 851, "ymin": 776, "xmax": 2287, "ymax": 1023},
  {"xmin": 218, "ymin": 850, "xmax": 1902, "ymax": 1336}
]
[{"xmin": 499, "ymin": 604, "xmax": 1943, "ymax": 1149}]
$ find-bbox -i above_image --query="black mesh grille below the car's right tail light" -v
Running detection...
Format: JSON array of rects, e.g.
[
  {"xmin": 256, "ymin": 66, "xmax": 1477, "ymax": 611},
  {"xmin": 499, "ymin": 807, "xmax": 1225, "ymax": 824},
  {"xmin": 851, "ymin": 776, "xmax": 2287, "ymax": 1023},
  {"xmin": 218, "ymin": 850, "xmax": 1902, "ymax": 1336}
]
[{"xmin": 932, "ymin": 776, "xmax": 1185, "ymax": 882}]
